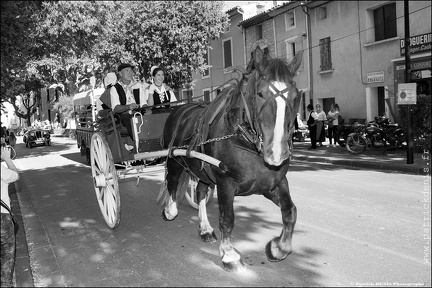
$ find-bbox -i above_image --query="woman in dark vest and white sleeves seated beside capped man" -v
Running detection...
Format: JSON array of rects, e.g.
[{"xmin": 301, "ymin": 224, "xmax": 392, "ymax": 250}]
[{"xmin": 146, "ymin": 66, "xmax": 177, "ymax": 113}]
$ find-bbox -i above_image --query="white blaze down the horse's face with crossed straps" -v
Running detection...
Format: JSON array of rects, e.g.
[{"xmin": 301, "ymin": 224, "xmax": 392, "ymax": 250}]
[{"xmin": 270, "ymin": 81, "xmax": 288, "ymax": 164}]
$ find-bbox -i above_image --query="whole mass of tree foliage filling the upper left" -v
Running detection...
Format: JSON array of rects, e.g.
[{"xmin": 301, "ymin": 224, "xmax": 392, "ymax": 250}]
[{"xmin": 1, "ymin": 1, "xmax": 228, "ymax": 120}]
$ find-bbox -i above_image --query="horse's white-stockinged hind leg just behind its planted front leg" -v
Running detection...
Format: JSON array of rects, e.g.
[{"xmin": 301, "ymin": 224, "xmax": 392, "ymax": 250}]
[{"xmin": 196, "ymin": 181, "xmax": 217, "ymax": 242}]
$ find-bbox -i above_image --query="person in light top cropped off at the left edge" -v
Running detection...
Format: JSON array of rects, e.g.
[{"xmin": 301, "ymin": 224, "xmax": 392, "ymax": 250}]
[{"xmin": 1, "ymin": 146, "xmax": 19, "ymax": 287}]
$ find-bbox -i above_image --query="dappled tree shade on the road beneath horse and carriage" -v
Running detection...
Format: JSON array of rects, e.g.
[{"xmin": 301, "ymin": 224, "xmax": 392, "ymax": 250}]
[{"xmin": 16, "ymin": 161, "xmax": 321, "ymax": 286}]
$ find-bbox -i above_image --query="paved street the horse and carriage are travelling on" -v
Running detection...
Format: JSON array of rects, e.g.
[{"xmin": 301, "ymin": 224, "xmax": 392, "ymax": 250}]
[{"xmin": 11, "ymin": 138, "xmax": 431, "ymax": 287}]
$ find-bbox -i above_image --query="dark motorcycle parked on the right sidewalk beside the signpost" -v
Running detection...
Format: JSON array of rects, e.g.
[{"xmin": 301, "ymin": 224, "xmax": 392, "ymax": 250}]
[{"xmin": 345, "ymin": 117, "xmax": 406, "ymax": 154}]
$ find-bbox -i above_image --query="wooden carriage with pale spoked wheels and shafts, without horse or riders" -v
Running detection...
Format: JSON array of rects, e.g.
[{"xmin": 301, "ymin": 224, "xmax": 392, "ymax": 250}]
[{"xmin": 74, "ymin": 84, "xmax": 220, "ymax": 228}]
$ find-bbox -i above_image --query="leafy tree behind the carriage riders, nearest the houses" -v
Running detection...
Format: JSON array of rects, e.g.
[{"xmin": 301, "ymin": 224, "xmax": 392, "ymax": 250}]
[{"xmin": 120, "ymin": 1, "xmax": 228, "ymax": 89}]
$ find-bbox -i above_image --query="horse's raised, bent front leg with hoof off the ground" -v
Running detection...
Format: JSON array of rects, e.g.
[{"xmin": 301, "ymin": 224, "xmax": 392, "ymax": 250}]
[{"xmin": 264, "ymin": 177, "xmax": 297, "ymax": 262}]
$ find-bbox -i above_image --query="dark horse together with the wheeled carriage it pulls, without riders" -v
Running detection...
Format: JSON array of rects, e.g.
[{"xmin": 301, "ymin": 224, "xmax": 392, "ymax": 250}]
[{"xmin": 77, "ymin": 47, "xmax": 303, "ymax": 271}]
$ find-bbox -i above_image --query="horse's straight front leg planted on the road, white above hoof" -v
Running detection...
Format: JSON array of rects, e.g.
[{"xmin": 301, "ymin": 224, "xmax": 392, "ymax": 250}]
[{"xmin": 218, "ymin": 182, "xmax": 245, "ymax": 272}]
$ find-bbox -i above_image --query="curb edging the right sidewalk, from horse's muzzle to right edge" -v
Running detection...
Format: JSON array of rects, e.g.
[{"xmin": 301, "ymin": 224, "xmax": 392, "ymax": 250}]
[{"xmin": 293, "ymin": 155, "xmax": 429, "ymax": 175}]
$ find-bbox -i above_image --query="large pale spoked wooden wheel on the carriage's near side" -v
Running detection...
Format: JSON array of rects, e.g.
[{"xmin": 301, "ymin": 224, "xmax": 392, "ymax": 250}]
[{"xmin": 90, "ymin": 132, "xmax": 120, "ymax": 228}]
